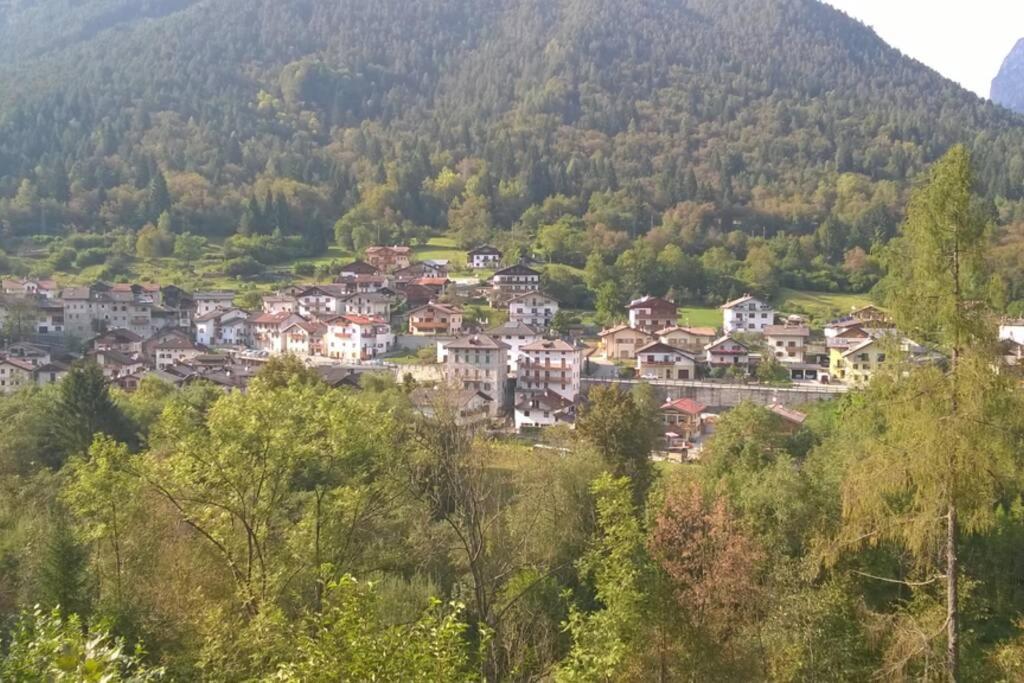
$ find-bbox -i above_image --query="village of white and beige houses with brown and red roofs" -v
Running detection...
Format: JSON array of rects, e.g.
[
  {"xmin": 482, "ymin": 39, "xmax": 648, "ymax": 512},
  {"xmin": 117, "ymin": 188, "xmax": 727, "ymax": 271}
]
[{"xmin": 0, "ymin": 246, "xmax": 1024, "ymax": 459}]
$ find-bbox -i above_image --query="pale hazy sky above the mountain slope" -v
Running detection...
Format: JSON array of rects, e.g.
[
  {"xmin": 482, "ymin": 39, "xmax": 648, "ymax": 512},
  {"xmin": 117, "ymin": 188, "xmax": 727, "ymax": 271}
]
[{"xmin": 825, "ymin": 0, "xmax": 1024, "ymax": 97}]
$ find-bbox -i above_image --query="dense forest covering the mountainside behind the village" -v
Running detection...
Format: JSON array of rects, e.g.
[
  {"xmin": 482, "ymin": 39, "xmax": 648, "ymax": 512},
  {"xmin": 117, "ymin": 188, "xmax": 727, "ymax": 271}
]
[{"xmin": 0, "ymin": 0, "xmax": 1024, "ymax": 307}]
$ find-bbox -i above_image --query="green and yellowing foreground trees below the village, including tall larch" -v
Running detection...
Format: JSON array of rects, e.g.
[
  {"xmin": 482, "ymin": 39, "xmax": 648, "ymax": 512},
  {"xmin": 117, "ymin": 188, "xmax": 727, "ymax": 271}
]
[{"xmin": 6, "ymin": 147, "xmax": 1024, "ymax": 682}]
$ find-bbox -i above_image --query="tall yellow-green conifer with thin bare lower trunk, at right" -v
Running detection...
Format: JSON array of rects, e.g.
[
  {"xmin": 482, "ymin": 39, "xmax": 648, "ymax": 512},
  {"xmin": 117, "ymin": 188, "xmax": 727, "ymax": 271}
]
[{"xmin": 841, "ymin": 146, "xmax": 1020, "ymax": 681}]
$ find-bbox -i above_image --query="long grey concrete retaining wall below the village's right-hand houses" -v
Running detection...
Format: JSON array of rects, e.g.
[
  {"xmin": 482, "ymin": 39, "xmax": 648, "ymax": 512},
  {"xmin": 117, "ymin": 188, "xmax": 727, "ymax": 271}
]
[{"xmin": 583, "ymin": 377, "xmax": 849, "ymax": 408}]
